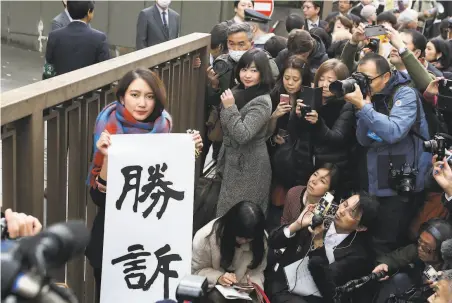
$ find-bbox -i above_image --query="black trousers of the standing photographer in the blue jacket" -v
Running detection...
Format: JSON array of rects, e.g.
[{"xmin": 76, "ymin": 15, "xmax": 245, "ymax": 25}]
[{"xmin": 369, "ymin": 192, "xmax": 425, "ymax": 256}]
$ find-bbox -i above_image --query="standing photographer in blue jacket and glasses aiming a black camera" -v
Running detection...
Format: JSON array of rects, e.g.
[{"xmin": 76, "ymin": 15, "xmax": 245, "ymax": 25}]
[{"xmin": 338, "ymin": 53, "xmax": 431, "ymax": 254}]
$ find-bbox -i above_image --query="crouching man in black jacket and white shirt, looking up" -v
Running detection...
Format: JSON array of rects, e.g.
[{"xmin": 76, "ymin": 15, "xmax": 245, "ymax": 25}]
[{"xmin": 265, "ymin": 192, "xmax": 378, "ymax": 303}]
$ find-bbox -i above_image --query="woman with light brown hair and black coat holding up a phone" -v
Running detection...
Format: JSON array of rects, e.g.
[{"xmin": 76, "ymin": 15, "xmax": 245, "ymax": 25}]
[{"xmin": 289, "ymin": 59, "xmax": 356, "ymax": 189}]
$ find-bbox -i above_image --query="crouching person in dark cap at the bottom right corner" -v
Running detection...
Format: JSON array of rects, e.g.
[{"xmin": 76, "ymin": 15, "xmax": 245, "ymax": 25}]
[{"xmin": 373, "ymin": 219, "xmax": 452, "ymax": 303}]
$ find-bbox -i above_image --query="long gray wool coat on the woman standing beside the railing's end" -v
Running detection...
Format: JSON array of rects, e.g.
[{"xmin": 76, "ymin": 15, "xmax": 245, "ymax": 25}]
[{"xmin": 217, "ymin": 94, "xmax": 272, "ymax": 217}]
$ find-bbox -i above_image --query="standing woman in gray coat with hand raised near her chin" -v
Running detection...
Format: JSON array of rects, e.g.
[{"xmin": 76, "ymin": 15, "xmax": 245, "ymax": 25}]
[{"xmin": 217, "ymin": 49, "xmax": 273, "ymax": 217}]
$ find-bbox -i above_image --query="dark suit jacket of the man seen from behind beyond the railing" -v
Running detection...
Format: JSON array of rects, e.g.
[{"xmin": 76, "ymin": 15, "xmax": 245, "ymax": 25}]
[{"xmin": 46, "ymin": 21, "xmax": 110, "ymax": 75}]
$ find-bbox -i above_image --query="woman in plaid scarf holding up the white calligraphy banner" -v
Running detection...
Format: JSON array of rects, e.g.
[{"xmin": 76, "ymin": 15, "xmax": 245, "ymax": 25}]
[{"xmin": 85, "ymin": 68, "xmax": 202, "ymax": 302}]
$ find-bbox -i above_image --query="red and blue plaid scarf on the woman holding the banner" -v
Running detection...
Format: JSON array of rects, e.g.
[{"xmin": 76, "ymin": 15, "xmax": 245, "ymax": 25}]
[{"xmin": 86, "ymin": 101, "xmax": 172, "ymax": 187}]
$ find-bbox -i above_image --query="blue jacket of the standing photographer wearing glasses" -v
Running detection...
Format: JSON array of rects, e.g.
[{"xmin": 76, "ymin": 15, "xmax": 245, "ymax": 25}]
[{"xmin": 356, "ymin": 71, "xmax": 432, "ymax": 197}]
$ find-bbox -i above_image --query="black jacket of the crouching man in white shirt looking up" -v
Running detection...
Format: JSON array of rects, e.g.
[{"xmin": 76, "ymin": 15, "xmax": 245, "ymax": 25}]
[{"xmin": 265, "ymin": 225, "xmax": 372, "ymax": 303}]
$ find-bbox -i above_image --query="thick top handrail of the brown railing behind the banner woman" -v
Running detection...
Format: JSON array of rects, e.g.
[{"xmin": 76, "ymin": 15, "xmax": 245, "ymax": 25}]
[{"xmin": 0, "ymin": 33, "xmax": 210, "ymax": 126}]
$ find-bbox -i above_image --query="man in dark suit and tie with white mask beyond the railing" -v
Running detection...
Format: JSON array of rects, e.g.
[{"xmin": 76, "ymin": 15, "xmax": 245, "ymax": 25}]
[{"xmin": 136, "ymin": 0, "xmax": 180, "ymax": 50}]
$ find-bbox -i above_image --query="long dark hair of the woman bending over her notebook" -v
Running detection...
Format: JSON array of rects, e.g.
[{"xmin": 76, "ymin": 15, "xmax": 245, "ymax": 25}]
[{"xmin": 209, "ymin": 201, "xmax": 265, "ymax": 270}]
